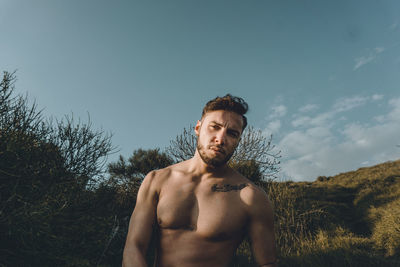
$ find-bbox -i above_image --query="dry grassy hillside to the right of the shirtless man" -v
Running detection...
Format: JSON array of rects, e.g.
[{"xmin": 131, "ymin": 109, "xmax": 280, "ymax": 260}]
[{"xmin": 236, "ymin": 160, "xmax": 400, "ymax": 266}]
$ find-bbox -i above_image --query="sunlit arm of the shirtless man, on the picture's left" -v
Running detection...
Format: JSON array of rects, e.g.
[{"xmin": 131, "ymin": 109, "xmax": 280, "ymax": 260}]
[{"xmin": 122, "ymin": 171, "xmax": 158, "ymax": 267}]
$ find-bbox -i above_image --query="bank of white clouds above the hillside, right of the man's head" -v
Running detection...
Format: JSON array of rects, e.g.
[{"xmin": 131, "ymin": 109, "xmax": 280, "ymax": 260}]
[{"xmin": 277, "ymin": 95, "xmax": 400, "ymax": 180}]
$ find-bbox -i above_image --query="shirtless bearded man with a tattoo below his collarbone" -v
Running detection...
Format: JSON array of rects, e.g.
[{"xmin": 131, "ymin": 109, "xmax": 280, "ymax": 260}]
[{"xmin": 123, "ymin": 94, "xmax": 276, "ymax": 267}]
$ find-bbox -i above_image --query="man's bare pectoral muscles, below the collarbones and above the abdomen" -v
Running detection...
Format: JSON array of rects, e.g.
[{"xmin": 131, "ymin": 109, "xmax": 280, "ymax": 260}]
[{"xmin": 157, "ymin": 184, "xmax": 247, "ymax": 239}]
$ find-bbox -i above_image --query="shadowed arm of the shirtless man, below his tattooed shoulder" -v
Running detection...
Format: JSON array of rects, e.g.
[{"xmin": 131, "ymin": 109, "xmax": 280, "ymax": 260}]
[{"xmin": 245, "ymin": 188, "xmax": 277, "ymax": 267}]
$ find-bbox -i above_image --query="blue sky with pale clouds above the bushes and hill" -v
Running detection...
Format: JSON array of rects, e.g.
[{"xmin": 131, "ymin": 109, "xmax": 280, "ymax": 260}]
[{"xmin": 0, "ymin": 0, "xmax": 400, "ymax": 180}]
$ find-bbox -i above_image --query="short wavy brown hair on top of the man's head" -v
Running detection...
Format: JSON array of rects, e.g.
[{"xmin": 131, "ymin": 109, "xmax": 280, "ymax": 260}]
[{"xmin": 201, "ymin": 94, "xmax": 249, "ymax": 130}]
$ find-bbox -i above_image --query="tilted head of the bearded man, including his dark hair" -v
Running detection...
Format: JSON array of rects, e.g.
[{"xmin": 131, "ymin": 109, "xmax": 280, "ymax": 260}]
[{"xmin": 195, "ymin": 94, "xmax": 248, "ymax": 167}]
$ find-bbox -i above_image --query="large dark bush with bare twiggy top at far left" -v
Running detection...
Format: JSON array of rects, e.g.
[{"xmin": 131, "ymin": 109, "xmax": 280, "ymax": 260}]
[{"xmin": 0, "ymin": 72, "xmax": 113, "ymax": 266}]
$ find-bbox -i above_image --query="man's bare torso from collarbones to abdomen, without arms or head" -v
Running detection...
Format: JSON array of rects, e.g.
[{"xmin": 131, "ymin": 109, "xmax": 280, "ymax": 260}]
[{"xmin": 156, "ymin": 166, "xmax": 253, "ymax": 267}]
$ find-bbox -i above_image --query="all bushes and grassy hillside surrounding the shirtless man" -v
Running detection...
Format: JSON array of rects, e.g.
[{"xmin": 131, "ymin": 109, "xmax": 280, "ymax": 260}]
[{"xmin": 0, "ymin": 72, "xmax": 400, "ymax": 267}]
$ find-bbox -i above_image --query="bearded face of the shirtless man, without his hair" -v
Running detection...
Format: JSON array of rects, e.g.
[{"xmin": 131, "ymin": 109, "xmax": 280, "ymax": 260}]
[{"xmin": 195, "ymin": 110, "xmax": 243, "ymax": 167}]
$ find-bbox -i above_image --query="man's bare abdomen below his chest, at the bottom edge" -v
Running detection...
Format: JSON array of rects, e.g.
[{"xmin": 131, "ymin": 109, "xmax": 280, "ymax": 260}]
[{"xmin": 155, "ymin": 228, "xmax": 241, "ymax": 267}]
